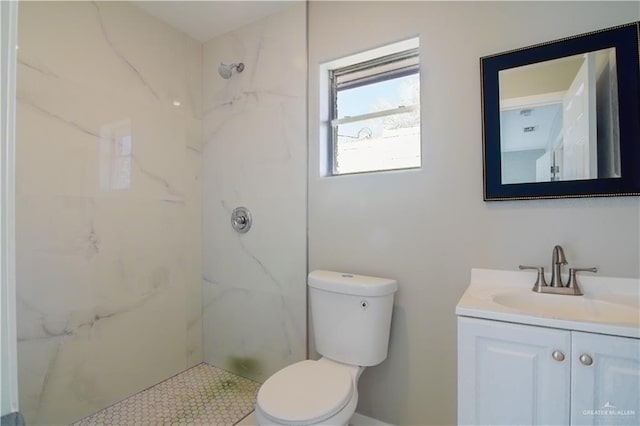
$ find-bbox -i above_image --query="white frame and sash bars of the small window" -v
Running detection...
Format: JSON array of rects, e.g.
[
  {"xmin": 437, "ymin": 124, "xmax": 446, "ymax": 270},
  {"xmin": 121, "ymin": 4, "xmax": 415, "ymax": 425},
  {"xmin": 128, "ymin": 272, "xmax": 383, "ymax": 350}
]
[{"xmin": 319, "ymin": 37, "xmax": 420, "ymax": 177}]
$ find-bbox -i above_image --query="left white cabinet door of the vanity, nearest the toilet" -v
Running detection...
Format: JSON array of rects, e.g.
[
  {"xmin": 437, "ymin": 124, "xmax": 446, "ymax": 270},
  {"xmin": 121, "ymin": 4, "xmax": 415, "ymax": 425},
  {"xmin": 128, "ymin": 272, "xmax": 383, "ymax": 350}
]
[{"xmin": 458, "ymin": 317, "xmax": 571, "ymax": 425}]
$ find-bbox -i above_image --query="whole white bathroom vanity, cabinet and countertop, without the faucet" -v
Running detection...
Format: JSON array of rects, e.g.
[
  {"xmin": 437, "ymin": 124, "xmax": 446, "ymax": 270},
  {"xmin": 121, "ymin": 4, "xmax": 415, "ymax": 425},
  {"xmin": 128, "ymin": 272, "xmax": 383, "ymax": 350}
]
[{"xmin": 456, "ymin": 269, "xmax": 640, "ymax": 425}]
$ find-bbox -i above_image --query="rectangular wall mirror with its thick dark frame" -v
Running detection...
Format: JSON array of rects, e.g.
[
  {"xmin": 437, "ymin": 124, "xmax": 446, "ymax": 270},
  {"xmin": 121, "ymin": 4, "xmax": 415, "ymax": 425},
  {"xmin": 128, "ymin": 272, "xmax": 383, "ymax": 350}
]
[{"xmin": 480, "ymin": 22, "xmax": 640, "ymax": 201}]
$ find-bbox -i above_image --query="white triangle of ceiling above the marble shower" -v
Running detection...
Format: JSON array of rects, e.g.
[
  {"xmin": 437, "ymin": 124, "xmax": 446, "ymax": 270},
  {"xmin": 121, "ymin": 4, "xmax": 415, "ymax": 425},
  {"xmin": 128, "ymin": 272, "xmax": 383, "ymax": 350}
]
[{"xmin": 133, "ymin": 0, "xmax": 301, "ymax": 42}]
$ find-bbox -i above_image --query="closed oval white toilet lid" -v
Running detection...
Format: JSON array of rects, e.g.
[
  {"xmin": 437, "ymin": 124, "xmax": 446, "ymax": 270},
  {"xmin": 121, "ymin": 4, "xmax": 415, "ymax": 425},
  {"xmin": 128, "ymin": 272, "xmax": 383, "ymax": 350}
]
[{"xmin": 257, "ymin": 360, "xmax": 353, "ymax": 424}]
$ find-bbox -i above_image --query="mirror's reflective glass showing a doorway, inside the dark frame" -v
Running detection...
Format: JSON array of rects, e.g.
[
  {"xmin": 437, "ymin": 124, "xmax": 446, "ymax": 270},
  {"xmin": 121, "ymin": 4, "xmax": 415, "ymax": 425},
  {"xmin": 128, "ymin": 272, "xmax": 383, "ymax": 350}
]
[{"xmin": 499, "ymin": 48, "xmax": 620, "ymax": 184}]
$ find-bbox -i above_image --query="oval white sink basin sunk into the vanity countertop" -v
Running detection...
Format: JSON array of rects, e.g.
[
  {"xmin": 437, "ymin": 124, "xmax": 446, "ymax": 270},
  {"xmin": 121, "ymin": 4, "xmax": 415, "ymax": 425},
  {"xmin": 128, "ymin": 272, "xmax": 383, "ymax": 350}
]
[{"xmin": 493, "ymin": 291, "xmax": 638, "ymax": 325}]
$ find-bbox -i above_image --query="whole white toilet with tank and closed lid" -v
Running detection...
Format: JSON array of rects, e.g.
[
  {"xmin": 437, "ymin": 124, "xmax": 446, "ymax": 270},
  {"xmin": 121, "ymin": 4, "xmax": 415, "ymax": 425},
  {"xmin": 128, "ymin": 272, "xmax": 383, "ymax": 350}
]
[{"xmin": 255, "ymin": 271, "xmax": 398, "ymax": 425}]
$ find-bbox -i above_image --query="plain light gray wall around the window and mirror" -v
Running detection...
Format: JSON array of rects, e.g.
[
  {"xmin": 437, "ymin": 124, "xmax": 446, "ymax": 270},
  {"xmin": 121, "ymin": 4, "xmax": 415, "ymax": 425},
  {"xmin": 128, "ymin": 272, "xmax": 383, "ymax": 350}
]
[{"xmin": 308, "ymin": 2, "xmax": 640, "ymax": 424}]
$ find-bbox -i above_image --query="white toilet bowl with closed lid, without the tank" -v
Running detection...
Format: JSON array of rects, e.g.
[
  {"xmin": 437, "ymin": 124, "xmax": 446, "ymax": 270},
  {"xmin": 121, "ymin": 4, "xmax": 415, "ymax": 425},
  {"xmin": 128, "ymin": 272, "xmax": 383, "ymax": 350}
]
[{"xmin": 255, "ymin": 358, "xmax": 364, "ymax": 425}]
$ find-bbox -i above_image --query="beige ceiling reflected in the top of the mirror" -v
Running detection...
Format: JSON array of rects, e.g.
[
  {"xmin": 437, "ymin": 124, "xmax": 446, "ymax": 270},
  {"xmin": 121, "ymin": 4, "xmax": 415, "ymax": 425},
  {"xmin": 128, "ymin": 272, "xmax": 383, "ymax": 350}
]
[{"xmin": 499, "ymin": 55, "xmax": 584, "ymax": 100}]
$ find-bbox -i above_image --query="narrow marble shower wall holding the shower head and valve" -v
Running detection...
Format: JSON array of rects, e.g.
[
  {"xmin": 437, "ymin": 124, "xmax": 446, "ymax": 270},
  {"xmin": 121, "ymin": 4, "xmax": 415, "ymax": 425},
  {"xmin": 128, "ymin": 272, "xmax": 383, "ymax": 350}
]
[{"xmin": 202, "ymin": 2, "xmax": 307, "ymax": 381}]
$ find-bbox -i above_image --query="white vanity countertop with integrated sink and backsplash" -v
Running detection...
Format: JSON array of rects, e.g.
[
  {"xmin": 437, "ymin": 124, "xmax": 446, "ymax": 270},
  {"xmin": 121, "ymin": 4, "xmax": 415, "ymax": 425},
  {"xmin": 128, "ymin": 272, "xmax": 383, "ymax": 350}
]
[{"xmin": 456, "ymin": 269, "xmax": 640, "ymax": 338}]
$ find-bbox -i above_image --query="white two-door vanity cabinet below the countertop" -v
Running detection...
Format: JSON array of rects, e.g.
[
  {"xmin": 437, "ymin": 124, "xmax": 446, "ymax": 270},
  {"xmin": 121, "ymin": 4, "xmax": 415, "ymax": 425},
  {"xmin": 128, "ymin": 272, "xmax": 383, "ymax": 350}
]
[{"xmin": 458, "ymin": 316, "xmax": 640, "ymax": 425}]
